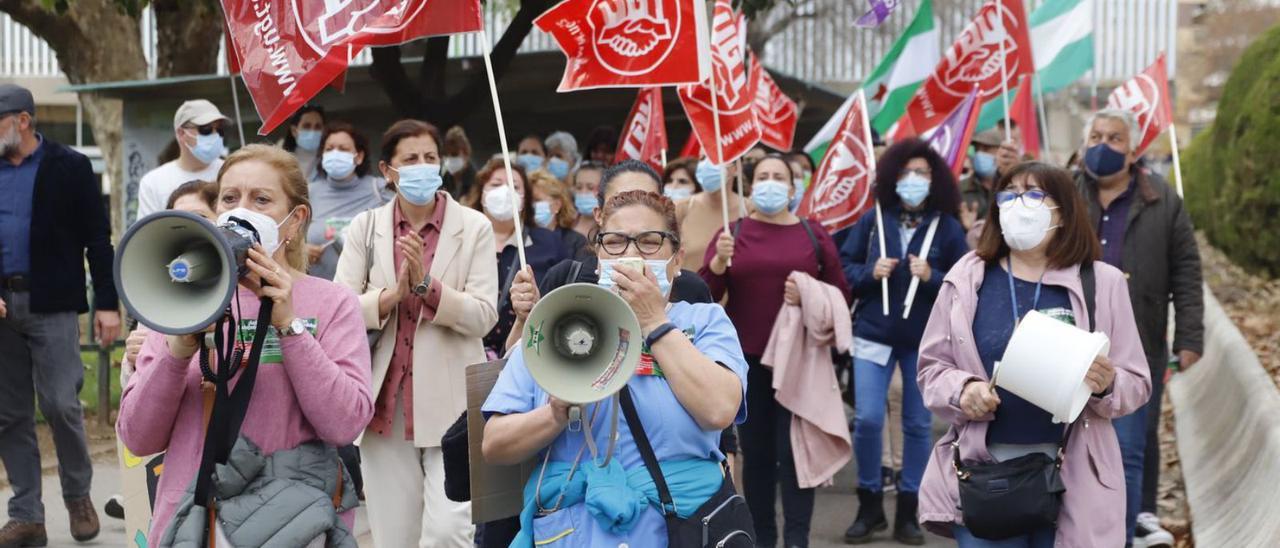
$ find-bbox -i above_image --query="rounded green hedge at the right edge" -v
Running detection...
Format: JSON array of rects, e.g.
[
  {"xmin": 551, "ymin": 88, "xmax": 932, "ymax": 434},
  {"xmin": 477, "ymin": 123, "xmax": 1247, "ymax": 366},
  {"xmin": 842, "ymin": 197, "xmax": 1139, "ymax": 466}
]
[{"xmin": 1181, "ymin": 26, "xmax": 1280, "ymax": 278}]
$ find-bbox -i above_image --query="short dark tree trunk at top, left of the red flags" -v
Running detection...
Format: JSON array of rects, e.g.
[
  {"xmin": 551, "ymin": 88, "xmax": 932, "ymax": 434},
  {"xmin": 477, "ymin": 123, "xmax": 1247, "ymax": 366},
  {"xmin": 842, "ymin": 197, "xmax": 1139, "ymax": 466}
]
[{"xmin": 151, "ymin": 0, "xmax": 224, "ymax": 78}]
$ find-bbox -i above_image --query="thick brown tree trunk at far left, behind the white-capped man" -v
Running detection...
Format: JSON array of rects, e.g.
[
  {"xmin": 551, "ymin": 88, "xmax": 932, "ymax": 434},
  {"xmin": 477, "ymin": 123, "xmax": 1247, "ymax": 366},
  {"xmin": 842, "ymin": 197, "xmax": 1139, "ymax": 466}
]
[{"xmin": 0, "ymin": 0, "xmax": 147, "ymax": 236}]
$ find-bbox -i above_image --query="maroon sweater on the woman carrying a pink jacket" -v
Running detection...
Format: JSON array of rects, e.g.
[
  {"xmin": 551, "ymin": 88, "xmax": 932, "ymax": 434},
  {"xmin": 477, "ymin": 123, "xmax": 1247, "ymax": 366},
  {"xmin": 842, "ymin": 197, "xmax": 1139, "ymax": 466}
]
[{"xmin": 698, "ymin": 219, "xmax": 850, "ymax": 357}]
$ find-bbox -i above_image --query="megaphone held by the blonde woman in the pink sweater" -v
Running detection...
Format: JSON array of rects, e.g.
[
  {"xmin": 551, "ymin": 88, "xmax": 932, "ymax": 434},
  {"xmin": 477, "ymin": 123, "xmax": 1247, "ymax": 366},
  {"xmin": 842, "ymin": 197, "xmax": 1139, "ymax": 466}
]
[{"xmin": 115, "ymin": 210, "xmax": 259, "ymax": 334}]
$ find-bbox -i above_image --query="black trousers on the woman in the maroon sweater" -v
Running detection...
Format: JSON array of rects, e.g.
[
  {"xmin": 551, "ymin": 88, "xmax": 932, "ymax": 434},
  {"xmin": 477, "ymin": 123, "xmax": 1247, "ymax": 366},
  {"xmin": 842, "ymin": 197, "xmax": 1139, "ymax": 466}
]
[{"xmin": 737, "ymin": 356, "xmax": 815, "ymax": 548}]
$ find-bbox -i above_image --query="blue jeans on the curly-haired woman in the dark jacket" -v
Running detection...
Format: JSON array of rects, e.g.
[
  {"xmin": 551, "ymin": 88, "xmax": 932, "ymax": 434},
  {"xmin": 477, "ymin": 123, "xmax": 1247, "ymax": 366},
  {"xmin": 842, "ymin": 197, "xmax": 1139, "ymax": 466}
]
[{"xmin": 854, "ymin": 348, "xmax": 933, "ymax": 493}]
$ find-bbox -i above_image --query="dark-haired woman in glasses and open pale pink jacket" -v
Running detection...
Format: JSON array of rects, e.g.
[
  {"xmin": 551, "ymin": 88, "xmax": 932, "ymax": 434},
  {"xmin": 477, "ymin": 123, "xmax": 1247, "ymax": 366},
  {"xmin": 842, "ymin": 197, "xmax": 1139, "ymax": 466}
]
[{"xmin": 918, "ymin": 163, "xmax": 1151, "ymax": 547}]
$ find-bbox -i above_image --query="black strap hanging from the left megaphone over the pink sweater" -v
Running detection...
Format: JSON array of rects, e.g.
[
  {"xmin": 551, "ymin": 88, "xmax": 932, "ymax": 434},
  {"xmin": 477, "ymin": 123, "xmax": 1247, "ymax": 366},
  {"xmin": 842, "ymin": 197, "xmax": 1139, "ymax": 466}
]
[{"xmin": 195, "ymin": 297, "xmax": 274, "ymax": 508}]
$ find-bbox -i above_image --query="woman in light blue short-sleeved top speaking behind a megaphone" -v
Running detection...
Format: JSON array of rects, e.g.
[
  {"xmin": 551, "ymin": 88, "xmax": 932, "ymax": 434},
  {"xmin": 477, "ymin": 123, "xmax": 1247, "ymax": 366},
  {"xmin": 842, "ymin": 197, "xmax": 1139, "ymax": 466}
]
[{"xmin": 481, "ymin": 191, "xmax": 753, "ymax": 547}]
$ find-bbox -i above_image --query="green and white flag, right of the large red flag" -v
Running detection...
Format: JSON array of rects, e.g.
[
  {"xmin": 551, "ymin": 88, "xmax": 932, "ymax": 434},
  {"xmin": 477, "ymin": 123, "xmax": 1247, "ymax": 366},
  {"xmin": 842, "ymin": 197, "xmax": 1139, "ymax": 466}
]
[{"xmin": 978, "ymin": 0, "xmax": 1093, "ymax": 131}]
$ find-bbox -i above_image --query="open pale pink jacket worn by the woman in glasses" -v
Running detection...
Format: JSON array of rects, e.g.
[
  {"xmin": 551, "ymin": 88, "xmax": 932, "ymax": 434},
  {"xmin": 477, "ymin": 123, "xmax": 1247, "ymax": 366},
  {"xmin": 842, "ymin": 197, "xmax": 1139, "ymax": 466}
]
[{"xmin": 918, "ymin": 252, "xmax": 1151, "ymax": 548}]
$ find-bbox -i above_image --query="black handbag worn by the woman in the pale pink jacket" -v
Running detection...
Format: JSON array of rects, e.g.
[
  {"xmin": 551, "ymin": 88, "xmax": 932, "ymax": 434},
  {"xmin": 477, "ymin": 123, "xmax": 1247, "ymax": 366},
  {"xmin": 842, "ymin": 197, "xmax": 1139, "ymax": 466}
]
[{"xmin": 951, "ymin": 262, "xmax": 1097, "ymax": 540}]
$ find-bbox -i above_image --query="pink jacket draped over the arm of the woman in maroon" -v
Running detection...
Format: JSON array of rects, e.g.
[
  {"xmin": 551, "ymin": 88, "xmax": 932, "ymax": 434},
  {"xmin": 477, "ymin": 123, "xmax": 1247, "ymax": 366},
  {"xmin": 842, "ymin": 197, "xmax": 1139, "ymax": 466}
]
[{"xmin": 760, "ymin": 273, "xmax": 854, "ymax": 488}]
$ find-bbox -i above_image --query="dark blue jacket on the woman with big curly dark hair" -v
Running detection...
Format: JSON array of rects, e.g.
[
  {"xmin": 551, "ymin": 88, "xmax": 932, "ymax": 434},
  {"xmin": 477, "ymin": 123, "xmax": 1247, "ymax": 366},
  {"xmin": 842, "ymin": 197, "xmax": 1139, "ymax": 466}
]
[{"xmin": 840, "ymin": 207, "xmax": 969, "ymax": 348}]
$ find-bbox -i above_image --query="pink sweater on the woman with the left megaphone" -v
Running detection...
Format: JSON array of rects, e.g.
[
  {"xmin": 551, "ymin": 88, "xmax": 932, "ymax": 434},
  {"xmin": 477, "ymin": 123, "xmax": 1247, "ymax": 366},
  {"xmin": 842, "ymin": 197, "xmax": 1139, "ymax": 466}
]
[{"xmin": 115, "ymin": 277, "xmax": 374, "ymax": 543}]
